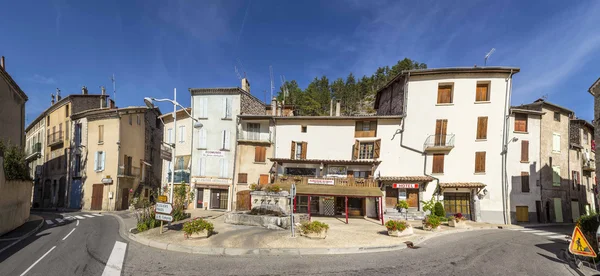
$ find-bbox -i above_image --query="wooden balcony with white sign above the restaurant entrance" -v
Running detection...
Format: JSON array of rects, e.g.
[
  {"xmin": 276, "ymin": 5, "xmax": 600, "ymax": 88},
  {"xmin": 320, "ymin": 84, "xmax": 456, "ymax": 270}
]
[{"xmin": 275, "ymin": 175, "xmax": 379, "ymax": 188}]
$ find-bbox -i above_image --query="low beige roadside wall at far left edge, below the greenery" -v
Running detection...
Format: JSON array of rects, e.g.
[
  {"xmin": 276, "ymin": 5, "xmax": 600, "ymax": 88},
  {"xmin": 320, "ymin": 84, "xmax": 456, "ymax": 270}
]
[{"xmin": 0, "ymin": 157, "xmax": 32, "ymax": 236}]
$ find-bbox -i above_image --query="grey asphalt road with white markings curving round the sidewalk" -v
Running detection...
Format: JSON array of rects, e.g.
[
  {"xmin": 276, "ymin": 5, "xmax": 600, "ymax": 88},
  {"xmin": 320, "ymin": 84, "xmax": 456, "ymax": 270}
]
[{"xmin": 0, "ymin": 213, "xmax": 582, "ymax": 276}]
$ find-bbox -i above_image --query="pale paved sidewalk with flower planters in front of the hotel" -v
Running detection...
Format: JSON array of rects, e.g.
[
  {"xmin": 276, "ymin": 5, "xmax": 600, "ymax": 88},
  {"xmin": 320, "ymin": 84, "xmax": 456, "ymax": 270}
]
[{"xmin": 114, "ymin": 210, "xmax": 509, "ymax": 255}]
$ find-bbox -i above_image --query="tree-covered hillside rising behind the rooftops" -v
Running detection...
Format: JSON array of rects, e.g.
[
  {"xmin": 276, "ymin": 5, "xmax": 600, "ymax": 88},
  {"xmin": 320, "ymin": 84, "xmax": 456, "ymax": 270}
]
[{"xmin": 277, "ymin": 58, "xmax": 427, "ymax": 116}]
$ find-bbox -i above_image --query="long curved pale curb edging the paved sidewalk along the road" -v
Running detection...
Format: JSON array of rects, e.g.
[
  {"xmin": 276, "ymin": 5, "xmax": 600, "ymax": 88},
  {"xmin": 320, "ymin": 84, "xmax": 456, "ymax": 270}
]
[{"xmin": 109, "ymin": 214, "xmax": 497, "ymax": 256}]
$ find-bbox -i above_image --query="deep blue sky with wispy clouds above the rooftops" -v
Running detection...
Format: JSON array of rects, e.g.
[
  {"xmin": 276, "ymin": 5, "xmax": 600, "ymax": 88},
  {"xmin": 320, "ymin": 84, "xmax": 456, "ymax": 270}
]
[{"xmin": 0, "ymin": 0, "xmax": 600, "ymax": 125}]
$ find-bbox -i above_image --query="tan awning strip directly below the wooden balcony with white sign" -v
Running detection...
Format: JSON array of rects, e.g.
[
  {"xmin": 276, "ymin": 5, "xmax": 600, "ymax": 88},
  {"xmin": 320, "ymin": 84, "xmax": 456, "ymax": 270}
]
[{"xmin": 279, "ymin": 183, "xmax": 383, "ymax": 197}]
